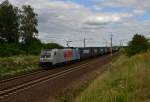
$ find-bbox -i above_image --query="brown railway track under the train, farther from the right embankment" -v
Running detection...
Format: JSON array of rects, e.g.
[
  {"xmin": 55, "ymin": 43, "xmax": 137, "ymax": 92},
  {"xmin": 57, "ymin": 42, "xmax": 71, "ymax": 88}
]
[{"xmin": 0, "ymin": 59, "xmax": 101, "ymax": 91}]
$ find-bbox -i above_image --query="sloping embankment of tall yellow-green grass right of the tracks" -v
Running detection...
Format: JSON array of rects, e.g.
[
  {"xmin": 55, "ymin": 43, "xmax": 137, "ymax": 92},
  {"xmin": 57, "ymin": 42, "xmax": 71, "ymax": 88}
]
[{"xmin": 75, "ymin": 52, "xmax": 150, "ymax": 102}]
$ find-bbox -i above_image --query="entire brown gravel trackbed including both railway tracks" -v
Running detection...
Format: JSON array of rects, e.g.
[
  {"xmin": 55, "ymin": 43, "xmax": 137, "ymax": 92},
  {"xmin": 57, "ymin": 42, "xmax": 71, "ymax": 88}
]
[{"xmin": 0, "ymin": 53, "xmax": 115, "ymax": 102}]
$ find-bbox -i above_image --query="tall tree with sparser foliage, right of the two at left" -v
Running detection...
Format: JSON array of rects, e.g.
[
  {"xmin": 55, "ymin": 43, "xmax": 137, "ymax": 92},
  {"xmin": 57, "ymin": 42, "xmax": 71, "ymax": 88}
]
[{"xmin": 20, "ymin": 5, "xmax": 38, "ymax": 44}]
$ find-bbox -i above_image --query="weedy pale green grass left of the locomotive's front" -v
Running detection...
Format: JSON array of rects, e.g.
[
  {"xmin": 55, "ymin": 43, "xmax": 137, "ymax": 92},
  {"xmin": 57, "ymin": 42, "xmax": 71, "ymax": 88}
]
[{"xmin": 0, "ymin": 56, "xmax": 39, "ymax": 79}]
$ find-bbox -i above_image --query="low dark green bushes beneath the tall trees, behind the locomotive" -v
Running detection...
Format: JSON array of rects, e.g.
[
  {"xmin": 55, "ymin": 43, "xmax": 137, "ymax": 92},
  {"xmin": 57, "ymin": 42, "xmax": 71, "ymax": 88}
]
[{"xmin": 0, "ymin": 39, "xmax": 63, "ymax": 57}]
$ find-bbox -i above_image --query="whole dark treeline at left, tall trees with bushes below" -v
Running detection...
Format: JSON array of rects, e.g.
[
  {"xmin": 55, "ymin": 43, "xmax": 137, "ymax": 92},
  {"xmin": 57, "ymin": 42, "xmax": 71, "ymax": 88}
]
[{"xmin": 0, "ymin": 0, "xmax": 62, "ymax": 56}]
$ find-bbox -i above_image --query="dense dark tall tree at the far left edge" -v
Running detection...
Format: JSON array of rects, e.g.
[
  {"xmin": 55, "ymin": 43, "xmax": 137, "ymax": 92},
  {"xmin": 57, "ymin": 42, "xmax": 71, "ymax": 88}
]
[{"xmin": 0, "ymin": 0, "xmax": 19, "ymax": 43}]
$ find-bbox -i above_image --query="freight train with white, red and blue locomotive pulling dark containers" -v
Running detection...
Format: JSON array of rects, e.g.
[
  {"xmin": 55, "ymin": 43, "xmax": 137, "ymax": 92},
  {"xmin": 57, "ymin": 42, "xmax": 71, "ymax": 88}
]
[{"xmin": 39, "ymin": 47, "xmax": 119, "ymax": 67}]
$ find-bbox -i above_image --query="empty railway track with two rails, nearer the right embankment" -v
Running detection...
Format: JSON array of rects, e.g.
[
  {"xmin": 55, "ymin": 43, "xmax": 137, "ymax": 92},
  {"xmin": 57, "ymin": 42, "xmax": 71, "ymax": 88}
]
[{"xmin": 0, "ymin": 58, "xmax": 101, "ymax": 99}]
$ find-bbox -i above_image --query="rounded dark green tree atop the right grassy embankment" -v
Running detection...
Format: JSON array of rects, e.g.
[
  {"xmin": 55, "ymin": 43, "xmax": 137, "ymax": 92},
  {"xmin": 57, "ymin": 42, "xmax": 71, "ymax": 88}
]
[{"xmin": 126, "ymin": 34, "xmax": 150, "ymax": 56}]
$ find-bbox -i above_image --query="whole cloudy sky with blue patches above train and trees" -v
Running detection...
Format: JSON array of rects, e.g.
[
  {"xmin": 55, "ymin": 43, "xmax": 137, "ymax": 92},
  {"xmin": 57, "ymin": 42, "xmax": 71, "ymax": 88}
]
[{"xmin": 0, "ymin": 0, "xmax": 150, "ymax": 47}]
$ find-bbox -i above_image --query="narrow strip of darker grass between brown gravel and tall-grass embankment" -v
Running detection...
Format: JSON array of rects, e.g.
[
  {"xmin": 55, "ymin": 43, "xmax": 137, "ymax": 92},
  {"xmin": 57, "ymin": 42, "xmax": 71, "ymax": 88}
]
[{"xmin": 54, "ymin": 53, "xmax": 120, "ymax": 102}]
